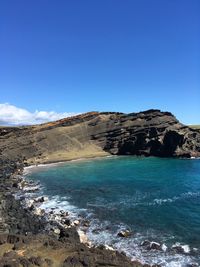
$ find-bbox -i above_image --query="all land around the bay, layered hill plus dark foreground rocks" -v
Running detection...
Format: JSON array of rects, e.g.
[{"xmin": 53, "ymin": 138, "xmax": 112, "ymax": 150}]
[{"xmin": 0, "ymin": 110, "xmax": 200, "ymax": 267}]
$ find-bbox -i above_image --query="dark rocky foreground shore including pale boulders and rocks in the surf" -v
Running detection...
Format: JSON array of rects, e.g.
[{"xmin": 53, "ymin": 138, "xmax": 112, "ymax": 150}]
[{"xmin": 0, "ymin": 158, "xmax": 198, "ymax": 267}]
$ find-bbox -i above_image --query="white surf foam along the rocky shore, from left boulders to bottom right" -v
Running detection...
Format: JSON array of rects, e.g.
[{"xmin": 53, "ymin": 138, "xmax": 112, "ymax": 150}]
[{"xmin": 33, "ymin": 195, "xmax": 199, "ymax": 267}]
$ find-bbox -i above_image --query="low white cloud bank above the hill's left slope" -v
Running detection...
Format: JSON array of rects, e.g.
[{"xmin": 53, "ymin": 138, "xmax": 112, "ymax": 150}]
[{"xmin": 0, "ymin": 103, "xmax": 76, "ymax": 125}]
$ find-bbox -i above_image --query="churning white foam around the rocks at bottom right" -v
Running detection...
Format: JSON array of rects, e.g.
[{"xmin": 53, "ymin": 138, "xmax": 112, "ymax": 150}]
[{"xmin": 86, "ymin": 219, "xmax": 198, "ymax": 267}]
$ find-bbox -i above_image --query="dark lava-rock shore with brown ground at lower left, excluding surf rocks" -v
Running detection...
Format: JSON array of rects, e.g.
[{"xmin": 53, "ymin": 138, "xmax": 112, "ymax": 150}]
[{"xmin": 0, "ymin": 159, "xmax": 143, "ymax": 267}]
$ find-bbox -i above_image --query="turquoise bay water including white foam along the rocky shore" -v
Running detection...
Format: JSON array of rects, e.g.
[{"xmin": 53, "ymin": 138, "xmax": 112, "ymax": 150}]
[{"xmin": 25, "ymin": 156, "xmax": 200, "ymax": 266}]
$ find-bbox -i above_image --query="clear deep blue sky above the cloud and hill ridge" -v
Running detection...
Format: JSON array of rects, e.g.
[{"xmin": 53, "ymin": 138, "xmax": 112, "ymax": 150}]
[{"xmin": 0, "ymin": 0, "xmax": 200, "ymax": 123}]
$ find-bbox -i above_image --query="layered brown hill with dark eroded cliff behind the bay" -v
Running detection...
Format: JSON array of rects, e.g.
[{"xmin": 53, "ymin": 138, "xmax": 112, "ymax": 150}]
[{"xmin": 0, "ymin": 110, "xmax": 200, "ymax": 164}]
